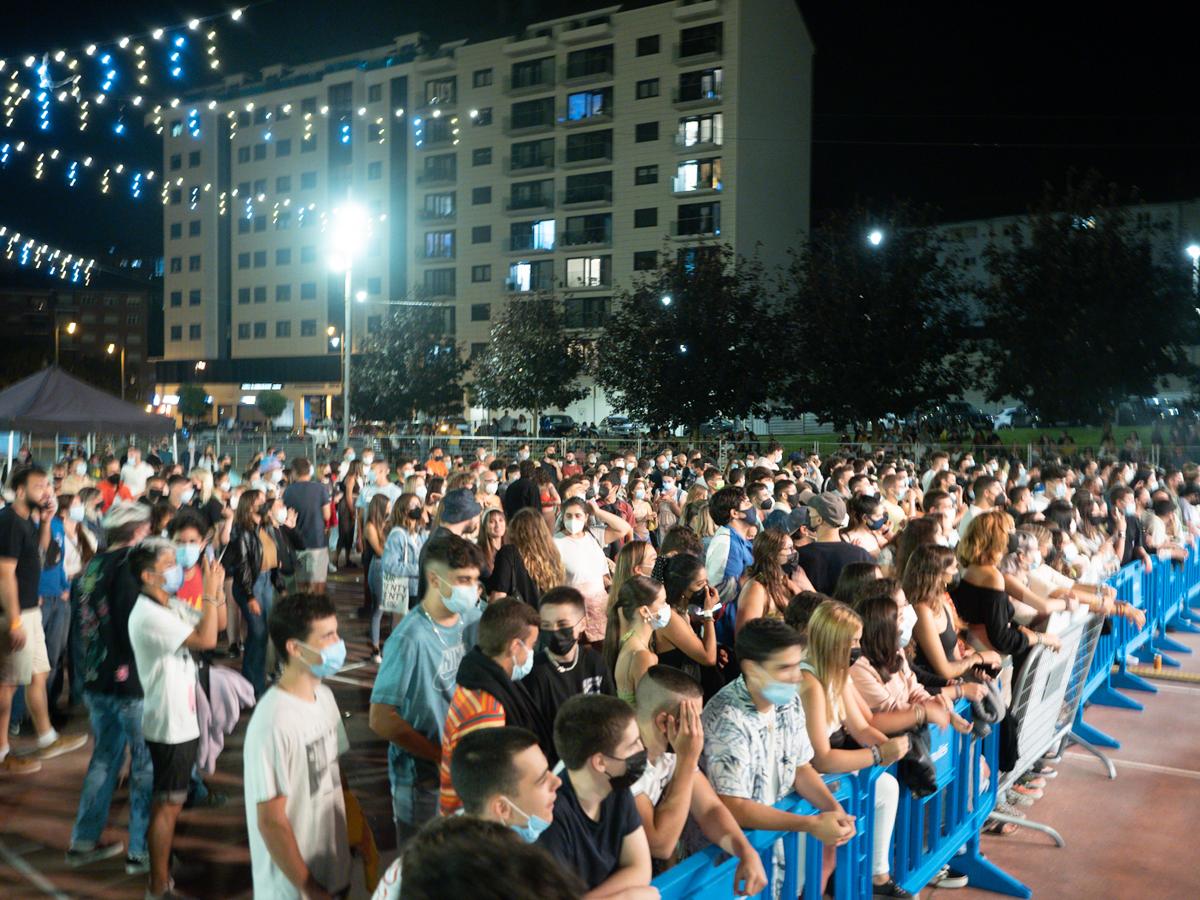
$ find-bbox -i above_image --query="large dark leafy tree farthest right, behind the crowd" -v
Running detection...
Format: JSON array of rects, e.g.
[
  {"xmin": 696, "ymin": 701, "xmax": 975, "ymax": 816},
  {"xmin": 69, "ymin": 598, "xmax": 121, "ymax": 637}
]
[{"xmin": 978, "ymin": 172, "xmax": 1200, "ymax": 422}]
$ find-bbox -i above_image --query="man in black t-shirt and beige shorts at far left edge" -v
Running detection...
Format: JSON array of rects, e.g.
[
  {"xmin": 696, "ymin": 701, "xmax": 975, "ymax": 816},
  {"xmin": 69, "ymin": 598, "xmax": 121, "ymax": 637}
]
[{"xmin": 0, "ymin": 466, "xmax": 88, "ymax": 776}]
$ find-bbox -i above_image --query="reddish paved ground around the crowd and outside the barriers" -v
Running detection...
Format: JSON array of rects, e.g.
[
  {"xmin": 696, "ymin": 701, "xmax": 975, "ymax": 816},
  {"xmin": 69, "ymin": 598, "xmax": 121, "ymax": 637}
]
[{"xmin": 0, "ymin": 575, "xmax": 1200, "ymax": 900}]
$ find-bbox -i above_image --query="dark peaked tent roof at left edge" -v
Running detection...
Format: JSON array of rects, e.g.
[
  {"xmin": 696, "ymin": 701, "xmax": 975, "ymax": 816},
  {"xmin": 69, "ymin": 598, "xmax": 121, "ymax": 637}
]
[{"xmin": 0, "ymin": 366, "xmax": 175, "ymax": 434}]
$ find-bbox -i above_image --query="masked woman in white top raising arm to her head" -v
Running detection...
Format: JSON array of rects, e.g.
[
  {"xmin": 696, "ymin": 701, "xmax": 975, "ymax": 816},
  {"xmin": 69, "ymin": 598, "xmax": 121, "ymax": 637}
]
[{"xmin": 554, "ymin": 497, "xmax": 634, "ymax": 643}]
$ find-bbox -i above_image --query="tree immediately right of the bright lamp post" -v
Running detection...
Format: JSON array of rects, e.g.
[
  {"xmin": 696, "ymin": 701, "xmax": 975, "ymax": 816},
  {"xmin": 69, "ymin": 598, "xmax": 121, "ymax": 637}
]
[{"xmin": 350, "ymin": 304, "xmax": 467, "ymax": 422}]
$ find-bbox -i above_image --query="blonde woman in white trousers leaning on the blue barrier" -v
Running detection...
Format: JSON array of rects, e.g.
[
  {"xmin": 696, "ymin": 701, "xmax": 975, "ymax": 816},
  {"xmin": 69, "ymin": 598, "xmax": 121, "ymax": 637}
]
[{"xmin": 800, "ymin": 600, "xmax": 912, "ymax": 898}]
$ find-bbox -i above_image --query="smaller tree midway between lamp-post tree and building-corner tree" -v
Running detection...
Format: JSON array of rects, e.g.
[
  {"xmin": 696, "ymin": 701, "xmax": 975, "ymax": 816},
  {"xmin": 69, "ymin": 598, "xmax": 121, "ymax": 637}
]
[{"xmin": 473, "ymin": 295, "xmax": 588, "ymax": 434}]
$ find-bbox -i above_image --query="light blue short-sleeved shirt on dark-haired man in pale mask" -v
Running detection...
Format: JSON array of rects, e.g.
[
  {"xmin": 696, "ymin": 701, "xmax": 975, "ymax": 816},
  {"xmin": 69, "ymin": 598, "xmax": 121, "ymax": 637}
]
[{"xmin": 371, "ymin": 606, "xmax": 481, "ymax": 790}]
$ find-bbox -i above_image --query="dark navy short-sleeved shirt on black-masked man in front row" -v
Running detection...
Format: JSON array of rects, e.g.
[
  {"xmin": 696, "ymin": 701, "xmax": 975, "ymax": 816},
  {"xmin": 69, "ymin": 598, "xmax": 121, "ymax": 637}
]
[{"xmin": 538, "ymin": 772, "xmax": 642, "ymax": 889}]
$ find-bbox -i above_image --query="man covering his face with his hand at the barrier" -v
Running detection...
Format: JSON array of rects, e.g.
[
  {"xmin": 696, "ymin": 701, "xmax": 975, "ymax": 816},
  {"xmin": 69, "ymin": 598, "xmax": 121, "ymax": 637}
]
[{"xmin": 632, "ymin": 666, "xmax": 767, "ymax": 895}]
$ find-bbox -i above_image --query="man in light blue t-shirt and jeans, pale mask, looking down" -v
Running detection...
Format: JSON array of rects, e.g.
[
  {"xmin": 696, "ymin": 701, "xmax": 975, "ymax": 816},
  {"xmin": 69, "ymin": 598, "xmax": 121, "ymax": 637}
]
[{"xmin": 370, "ymin": 535, "xmax": 482, "ymax": 836}]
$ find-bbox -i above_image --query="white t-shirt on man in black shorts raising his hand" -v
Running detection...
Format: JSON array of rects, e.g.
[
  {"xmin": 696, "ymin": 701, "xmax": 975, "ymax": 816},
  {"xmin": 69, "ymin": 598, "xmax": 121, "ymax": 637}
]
[{"xmin": 130, "ymin": 594, "xmax": 200, "ymax": 744}]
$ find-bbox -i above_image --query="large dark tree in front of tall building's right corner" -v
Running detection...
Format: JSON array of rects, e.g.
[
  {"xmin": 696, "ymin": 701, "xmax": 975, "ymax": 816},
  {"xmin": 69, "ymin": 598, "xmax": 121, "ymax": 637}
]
[{"xmin": 595, "ymin": 245, "xmax": 785, "ymax": 434}]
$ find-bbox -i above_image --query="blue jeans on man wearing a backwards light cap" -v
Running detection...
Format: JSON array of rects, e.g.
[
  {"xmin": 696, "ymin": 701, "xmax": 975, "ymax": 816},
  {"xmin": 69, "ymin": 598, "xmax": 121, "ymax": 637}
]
[{"xmin": 71, "ymin": 691, "xmax": 154, "ymax": 857}]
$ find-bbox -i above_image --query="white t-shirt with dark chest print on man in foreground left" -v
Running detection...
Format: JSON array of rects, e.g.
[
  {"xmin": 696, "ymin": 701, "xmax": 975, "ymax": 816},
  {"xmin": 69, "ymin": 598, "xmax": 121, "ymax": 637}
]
[{"xmin": 242, "ymin": 684, "xmax": 350, "ymax": 900}]
